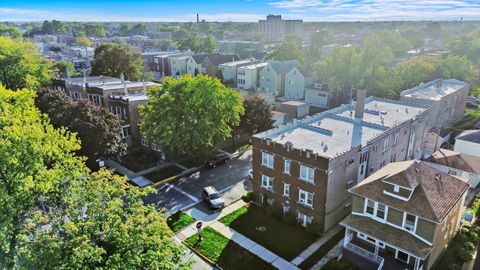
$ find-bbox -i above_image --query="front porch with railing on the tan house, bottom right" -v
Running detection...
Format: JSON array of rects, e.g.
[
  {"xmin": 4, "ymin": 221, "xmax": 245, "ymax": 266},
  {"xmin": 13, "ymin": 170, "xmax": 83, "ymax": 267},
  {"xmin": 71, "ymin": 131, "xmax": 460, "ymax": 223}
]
[{"xmin": 343, "ymin": 228, "xmax": 424, "ymax": 270}]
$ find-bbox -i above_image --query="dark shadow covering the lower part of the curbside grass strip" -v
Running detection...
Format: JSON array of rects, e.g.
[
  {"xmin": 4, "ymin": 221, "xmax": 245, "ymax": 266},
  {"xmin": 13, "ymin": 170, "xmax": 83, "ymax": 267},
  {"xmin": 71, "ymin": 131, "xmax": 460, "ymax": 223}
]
[{"xmin": 217, "ymin": 240, "xmax": 275, "ymax": 270}]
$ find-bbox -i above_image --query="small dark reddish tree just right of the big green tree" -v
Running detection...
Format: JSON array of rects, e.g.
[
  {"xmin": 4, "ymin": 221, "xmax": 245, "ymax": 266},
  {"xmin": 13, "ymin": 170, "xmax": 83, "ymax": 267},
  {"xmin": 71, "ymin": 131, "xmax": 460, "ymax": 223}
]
[{"xmin": 239, "ymin": 97, "xmax": 273, "ymax": 135}]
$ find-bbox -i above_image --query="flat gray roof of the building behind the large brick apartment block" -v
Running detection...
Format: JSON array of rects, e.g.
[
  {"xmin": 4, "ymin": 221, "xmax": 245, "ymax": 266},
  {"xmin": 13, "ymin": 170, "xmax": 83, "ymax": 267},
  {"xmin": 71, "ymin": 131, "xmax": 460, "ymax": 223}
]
[{"xmin": 400, "ymin": 79, "xmax": 467, "ymax": 100}]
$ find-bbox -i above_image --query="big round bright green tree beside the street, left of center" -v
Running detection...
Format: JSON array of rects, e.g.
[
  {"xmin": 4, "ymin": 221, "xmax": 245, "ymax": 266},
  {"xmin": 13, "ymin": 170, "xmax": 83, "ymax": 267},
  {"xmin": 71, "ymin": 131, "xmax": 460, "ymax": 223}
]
[{"xmin": 140, "ymin": 75, "xmax": 244, "ymax": 158}]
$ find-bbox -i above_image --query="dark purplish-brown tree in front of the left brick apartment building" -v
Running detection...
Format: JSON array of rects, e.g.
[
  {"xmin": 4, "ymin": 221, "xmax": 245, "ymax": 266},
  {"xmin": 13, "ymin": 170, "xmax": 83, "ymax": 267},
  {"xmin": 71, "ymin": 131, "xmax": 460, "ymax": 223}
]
[{"xmin": 37, "ymin": 90, "xmax": 126, "ymax": 168}]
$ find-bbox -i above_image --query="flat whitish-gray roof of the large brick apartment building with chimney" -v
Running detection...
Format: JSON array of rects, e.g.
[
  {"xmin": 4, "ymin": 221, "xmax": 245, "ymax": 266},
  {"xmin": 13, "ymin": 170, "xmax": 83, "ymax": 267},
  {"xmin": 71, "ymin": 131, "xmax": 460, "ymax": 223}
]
[{"xmin": 254, "ymin": 97, "xmax": 428, "ymax": 158}]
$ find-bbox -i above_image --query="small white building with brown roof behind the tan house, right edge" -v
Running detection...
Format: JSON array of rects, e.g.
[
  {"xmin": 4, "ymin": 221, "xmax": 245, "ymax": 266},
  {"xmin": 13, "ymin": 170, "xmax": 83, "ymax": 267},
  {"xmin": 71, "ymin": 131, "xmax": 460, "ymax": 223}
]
[{"xmin": 426, "ymin": 149, "xmax": 480, "ymax": 188}]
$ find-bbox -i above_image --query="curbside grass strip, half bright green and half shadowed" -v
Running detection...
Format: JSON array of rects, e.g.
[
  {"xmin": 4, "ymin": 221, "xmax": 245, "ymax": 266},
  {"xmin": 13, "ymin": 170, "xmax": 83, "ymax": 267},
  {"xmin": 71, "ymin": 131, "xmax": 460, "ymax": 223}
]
[{"xmin": 185, "ymin": 227, "xmax": 275, "ymax": 270}]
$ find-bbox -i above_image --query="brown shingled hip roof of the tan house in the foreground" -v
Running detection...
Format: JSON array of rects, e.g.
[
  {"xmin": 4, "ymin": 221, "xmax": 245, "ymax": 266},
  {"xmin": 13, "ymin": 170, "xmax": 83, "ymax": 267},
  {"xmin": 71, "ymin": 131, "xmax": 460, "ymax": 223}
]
[{"xmin": 350, "ymin": 160, "xmax": 468, "ymax": 223}]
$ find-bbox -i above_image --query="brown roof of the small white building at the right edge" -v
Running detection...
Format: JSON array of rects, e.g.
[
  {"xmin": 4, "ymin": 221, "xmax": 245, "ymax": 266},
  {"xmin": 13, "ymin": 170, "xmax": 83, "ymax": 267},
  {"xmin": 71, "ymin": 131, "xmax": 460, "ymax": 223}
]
[{"xmin": 427, "ymin": 149, "xmax": 480, "ymax": 174}]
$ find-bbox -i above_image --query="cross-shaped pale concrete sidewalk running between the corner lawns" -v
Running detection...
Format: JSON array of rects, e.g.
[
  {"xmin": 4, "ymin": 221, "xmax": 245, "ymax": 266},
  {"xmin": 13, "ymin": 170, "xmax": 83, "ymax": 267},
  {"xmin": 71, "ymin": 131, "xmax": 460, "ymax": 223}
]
[{"xmin": 177, "ymin": 200, "xmax": 299, "ymax": 270}]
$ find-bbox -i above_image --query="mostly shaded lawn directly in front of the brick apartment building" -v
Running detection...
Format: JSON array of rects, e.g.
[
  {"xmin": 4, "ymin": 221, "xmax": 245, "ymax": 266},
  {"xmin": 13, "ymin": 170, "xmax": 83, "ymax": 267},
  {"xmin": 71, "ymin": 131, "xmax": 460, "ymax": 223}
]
[{"xmin": 220, "ymin": 205, "xmax": 318, "ymax": 260}]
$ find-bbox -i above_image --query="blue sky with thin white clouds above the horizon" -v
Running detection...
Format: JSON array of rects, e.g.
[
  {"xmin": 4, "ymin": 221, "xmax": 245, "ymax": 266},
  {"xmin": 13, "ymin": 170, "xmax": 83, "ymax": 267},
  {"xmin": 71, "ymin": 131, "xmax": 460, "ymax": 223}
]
[{"xmin": 0, "ymin": 0, "xmax": 480, "ymax": 22}]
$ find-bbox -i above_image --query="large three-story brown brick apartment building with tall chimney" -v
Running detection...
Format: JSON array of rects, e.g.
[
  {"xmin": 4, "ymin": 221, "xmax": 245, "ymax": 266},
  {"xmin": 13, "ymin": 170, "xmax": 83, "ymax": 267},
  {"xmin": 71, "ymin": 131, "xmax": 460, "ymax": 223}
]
[{"xmin": 252, "ymin": 90, "xmax": 429, "ymax": 232}]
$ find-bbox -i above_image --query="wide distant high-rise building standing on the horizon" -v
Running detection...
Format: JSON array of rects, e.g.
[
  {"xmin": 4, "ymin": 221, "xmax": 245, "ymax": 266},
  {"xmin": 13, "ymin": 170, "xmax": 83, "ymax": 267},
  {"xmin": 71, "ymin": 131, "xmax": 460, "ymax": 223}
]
[{"xmin": 259, "ymin": 14, "xmax": 303, "ymax": 41}]
